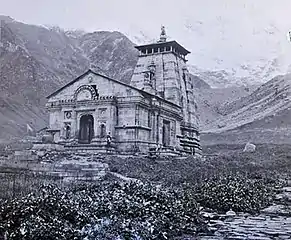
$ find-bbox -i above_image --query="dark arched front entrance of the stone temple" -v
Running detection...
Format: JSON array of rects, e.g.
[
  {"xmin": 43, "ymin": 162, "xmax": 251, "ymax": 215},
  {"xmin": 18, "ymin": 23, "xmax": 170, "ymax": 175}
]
[{"xmin": 79, "ymin": 115, "xmax": 94, "ymax": 143}]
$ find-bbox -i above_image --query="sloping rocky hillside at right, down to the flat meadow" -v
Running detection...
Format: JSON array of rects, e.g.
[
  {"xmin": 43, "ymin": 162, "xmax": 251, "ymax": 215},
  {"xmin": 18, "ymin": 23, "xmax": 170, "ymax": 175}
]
[{"xmin": 204, "ymin": 74, "xmax": 291, "ymax": 143}]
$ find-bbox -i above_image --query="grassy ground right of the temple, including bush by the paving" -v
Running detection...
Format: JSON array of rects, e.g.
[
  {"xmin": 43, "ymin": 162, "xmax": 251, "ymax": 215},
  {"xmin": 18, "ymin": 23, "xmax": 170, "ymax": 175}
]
[{"xmin": 102, "ymin": 142, "xmax": 291, "ymax": 213}]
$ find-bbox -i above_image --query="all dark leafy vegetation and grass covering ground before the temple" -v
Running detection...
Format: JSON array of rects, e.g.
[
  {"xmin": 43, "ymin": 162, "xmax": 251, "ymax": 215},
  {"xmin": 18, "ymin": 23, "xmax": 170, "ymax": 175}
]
[{"xmin": 0, "ymin": 145, "xmax": 291, "ymax": 239}]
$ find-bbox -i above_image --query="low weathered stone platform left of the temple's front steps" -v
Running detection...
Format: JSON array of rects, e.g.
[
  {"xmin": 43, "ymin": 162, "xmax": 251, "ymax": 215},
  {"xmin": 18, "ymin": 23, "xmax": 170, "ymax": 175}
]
[{"xmin": 0, "ymin": 150, "xmax": 109, "ymax": 182}]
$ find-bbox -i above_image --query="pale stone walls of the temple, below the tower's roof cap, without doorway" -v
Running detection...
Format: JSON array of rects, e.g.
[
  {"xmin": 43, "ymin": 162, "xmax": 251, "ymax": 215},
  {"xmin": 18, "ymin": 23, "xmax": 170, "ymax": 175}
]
[{"xmin": 47, "ymin": 52, "xmax": 199, "ymax": 154}]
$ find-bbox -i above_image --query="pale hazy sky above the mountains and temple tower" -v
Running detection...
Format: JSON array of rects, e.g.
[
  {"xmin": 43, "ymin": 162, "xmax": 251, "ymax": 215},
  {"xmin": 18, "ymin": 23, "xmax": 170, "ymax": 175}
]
[{"xmin": 0, "ymin": 0, "xmax": 291, "ymax": 76}]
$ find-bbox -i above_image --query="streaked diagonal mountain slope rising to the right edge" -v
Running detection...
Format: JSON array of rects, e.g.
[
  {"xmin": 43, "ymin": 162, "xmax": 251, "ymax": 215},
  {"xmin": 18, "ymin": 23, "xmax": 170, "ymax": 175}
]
[{"xmin": 207, "ymin": 74, "xmax": 291, "ymax": 132}]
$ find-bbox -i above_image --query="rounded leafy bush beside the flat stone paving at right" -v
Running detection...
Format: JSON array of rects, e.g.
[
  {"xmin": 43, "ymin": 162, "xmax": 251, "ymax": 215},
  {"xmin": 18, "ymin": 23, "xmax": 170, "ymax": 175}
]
[{"xmin": 195, "ymin": 175, "xmax": 273, "ymax": 213}]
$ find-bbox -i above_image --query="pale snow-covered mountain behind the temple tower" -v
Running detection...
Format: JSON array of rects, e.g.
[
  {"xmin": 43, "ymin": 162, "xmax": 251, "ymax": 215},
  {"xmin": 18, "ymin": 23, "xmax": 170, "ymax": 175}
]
[{"xmin": 127, "ymin": 26, "xmax": 291, "ymax": 88}]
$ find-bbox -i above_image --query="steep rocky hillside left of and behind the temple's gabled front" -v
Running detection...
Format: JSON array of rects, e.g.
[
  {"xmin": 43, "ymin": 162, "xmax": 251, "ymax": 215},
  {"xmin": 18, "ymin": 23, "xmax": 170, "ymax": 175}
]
[{"xmin": 0, "ymin": 16, "xmax": 137, "ymax": 139}]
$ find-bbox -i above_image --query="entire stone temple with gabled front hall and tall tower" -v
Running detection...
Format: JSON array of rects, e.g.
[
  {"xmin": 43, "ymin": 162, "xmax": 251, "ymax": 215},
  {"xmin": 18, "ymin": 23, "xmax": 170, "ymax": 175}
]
[{"xmin": 46, "ymin": 27, "xmax": 201, "ymax": 155}]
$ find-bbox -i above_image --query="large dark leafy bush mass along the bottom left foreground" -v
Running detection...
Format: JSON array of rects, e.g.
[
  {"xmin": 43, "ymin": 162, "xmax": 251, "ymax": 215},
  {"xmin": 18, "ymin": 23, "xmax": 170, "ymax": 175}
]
[{"xmin": 0, "ymin": 183, "xmax": 206, "ymax": 239}]
